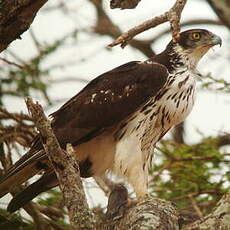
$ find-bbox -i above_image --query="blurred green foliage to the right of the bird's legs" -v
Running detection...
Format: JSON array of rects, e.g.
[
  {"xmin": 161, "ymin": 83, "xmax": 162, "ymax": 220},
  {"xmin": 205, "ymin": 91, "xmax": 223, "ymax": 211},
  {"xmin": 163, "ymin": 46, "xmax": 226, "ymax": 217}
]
[{"xmin": 151, "ymin": 137, "xmax": 230, "ymax": 218}]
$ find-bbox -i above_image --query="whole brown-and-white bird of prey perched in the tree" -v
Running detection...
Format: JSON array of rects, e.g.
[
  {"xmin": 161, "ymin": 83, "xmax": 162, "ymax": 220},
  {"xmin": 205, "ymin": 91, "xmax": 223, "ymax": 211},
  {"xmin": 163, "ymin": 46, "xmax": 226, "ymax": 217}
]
[{"xmin": 0, "ymin": 29, "xmax": 221, "ymax": 212}]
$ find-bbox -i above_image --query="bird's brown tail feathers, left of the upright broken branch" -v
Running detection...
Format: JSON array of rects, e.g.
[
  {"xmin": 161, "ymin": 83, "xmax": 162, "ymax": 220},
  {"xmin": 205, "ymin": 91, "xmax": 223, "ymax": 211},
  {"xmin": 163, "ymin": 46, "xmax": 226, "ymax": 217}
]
[{"xmin": 0, "ymin": 135, "xmax": 58, "ymax": 212}]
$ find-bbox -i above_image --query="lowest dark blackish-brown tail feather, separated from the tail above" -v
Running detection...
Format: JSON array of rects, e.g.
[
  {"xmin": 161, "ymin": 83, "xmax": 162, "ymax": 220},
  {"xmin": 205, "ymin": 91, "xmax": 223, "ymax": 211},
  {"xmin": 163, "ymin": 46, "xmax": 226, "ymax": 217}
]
[{"xmin": 7, "ymin": 170, "xmax": 58, "ymax": 213}]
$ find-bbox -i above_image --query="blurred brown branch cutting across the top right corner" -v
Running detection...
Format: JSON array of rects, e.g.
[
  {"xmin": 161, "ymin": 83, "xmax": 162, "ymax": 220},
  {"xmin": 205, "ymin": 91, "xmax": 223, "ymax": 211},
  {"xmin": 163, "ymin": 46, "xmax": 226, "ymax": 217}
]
[{"xmin": 207, "ymin": 0, "xmax": 230, "ymax": 30}]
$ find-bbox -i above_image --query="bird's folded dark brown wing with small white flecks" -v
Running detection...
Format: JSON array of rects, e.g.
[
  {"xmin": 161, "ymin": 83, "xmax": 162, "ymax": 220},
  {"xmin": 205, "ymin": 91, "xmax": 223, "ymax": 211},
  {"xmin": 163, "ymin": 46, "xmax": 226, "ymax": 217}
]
[{"xmin": 51, "ymin": 61, "xmax": 168, "ymax": 145}]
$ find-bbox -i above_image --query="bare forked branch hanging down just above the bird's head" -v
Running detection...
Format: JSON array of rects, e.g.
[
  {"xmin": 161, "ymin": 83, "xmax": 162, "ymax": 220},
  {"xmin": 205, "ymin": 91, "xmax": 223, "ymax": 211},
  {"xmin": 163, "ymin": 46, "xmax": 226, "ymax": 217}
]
[{"xmin": 109, "ymin": 0, "xmax": 187, "ymax": 48}]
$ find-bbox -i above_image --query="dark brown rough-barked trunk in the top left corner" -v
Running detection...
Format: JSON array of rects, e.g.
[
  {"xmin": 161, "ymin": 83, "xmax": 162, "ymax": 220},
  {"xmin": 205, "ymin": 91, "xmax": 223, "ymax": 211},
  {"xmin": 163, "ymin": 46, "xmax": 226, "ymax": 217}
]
[{"xmin": 0, "ymin": 0, "xmax": 48, "ymax": 52}]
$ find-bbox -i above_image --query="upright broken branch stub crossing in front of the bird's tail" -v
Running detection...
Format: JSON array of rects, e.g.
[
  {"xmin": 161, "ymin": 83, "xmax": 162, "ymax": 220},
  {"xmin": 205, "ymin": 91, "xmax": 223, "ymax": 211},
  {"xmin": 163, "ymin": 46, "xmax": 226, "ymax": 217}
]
[{"xmin": 26, "ymin": 98, "xmax": 94, "ymax": 230}]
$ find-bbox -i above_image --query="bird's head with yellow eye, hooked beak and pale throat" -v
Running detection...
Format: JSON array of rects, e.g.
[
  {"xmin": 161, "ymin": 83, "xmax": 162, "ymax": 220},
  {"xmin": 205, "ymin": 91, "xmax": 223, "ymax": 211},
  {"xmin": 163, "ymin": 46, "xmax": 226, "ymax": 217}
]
[{"xmin": 169, "ymin": 29, "xmax": 222, "ymax": 67}]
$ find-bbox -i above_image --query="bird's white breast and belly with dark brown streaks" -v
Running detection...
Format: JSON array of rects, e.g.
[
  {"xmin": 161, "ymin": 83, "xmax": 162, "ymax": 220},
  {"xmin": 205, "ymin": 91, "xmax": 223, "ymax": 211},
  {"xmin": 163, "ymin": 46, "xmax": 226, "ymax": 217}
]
[{"xmin": 114, "ymin": 68, "xmax": 195, "ymax": 181}]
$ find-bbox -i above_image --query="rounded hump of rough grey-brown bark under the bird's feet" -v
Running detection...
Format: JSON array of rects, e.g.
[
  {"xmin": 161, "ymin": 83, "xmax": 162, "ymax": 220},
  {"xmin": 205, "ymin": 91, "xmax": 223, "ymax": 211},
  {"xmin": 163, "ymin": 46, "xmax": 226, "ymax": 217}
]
[{"xmin": 104, "ymin": 198, "xmax": 179, "ymax": 230}]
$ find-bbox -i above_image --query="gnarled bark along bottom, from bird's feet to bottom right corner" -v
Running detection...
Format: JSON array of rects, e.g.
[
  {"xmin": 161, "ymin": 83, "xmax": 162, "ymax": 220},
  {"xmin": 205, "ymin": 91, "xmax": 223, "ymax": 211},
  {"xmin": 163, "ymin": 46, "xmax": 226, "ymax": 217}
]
[{"xmin": 100, "ymin": 192, "xmax": 230, "ymax": 230}]
